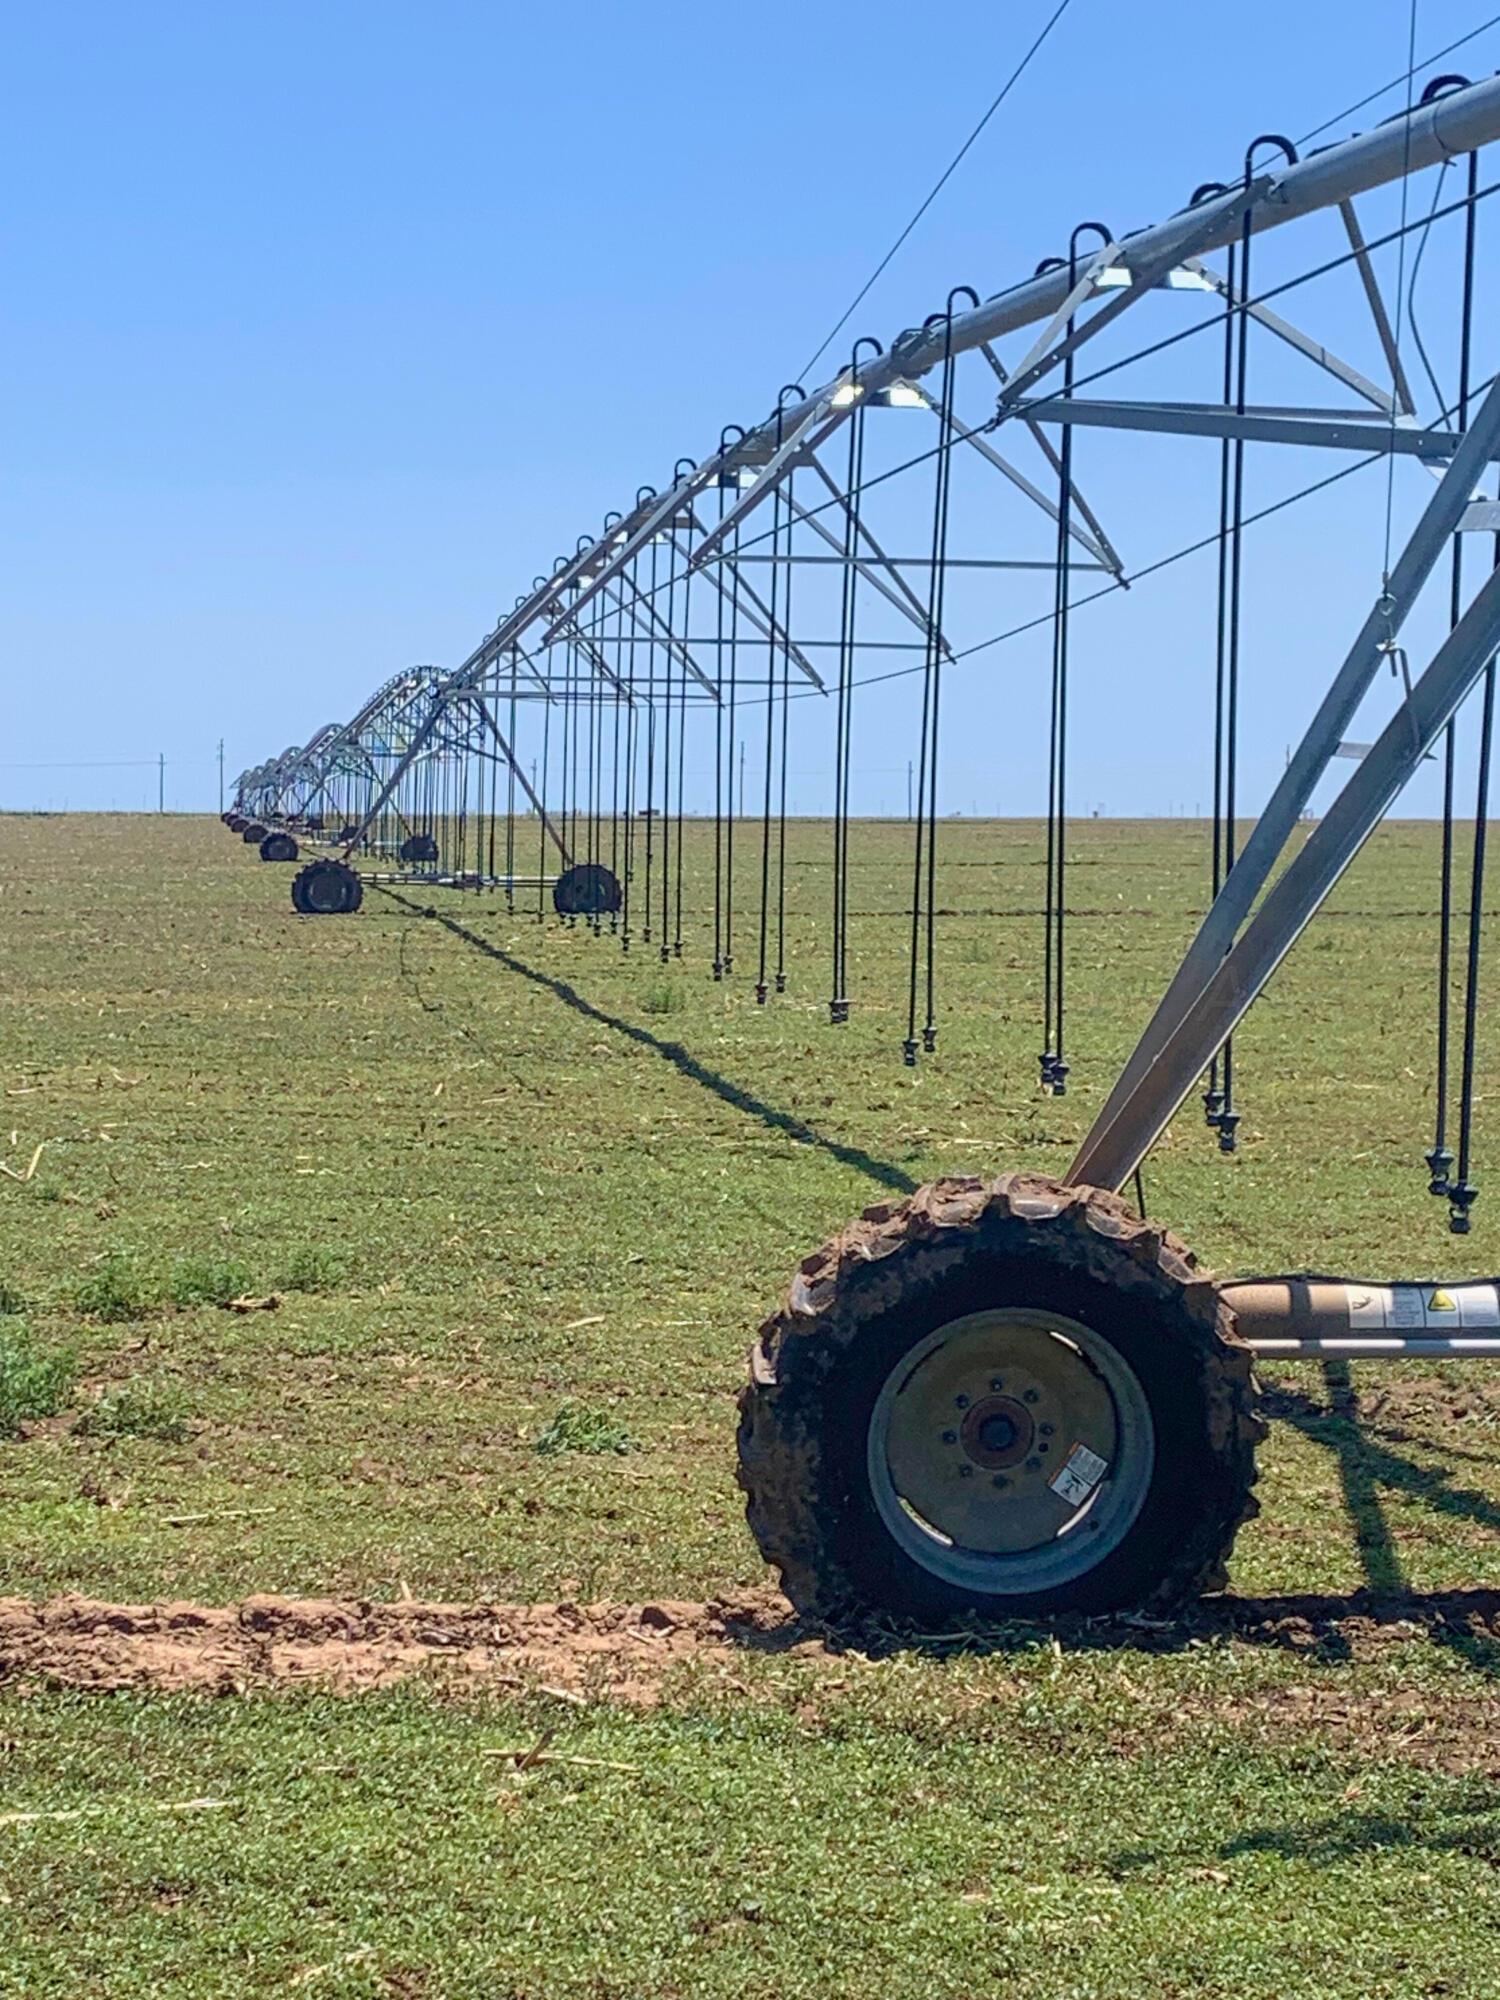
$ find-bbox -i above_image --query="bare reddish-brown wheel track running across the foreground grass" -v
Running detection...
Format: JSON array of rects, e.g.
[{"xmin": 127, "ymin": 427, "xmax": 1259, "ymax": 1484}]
[{"xmin": 0, "ymin": 1590, "xmax": 1500, "ymax": 1702}]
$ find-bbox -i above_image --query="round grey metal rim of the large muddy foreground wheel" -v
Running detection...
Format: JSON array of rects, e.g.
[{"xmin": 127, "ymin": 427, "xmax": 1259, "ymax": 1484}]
[{"xmin": 868, "ymin": 1308, "xmax": 1156, "ymax": 1596}]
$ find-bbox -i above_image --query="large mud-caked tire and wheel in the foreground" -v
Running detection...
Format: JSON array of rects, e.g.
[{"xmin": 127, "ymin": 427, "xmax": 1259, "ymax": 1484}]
[{"xmin": 740, "ymin": 1174, "xmax": 1264, "ymax": 1632}]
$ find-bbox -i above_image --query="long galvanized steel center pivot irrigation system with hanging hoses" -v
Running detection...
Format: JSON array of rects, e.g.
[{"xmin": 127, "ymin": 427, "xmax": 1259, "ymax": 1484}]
[{"xmin": 238, "ymin": 76, "xmax": 1500, "ymax": 1626}]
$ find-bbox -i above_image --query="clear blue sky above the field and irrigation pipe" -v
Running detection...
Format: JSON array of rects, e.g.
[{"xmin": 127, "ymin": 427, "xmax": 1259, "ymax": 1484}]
[{"xmin": 0, "ymin": 0, "xmax": 1500, "ymax": 810}]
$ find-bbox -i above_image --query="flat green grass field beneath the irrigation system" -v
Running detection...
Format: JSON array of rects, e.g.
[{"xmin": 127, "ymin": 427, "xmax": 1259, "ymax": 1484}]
[{"xmin": 0, "ymin": 818, "xmax": 1500, "ymax": 2000}]
